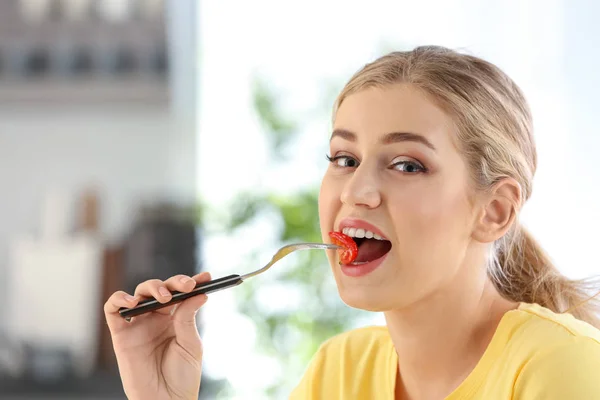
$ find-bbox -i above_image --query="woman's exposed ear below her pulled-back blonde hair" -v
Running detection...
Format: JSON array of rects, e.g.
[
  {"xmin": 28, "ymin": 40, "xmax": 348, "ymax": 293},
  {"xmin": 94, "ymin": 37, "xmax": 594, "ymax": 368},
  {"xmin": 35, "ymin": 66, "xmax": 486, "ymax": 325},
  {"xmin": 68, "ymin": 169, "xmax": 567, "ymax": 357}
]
[{"xmin": 473, "ymin": 178, "xmax": 521, "ymax": 243}]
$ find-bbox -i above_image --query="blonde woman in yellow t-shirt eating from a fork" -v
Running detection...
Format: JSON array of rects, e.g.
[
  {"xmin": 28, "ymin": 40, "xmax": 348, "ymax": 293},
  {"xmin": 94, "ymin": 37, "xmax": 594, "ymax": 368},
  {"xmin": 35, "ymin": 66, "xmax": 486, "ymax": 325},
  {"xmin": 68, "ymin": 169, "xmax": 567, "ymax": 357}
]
[{"xmin": 105, "ymin": 47, "xmax": 600, "ymax": 400}]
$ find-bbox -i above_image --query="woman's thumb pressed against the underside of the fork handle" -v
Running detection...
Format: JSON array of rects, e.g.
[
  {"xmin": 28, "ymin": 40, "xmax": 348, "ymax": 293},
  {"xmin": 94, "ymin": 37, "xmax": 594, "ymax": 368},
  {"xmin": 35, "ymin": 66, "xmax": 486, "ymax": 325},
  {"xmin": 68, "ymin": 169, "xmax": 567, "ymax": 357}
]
[{"xmin": 173, "ymin": 294, "xmax": 208, "ymax": 360}]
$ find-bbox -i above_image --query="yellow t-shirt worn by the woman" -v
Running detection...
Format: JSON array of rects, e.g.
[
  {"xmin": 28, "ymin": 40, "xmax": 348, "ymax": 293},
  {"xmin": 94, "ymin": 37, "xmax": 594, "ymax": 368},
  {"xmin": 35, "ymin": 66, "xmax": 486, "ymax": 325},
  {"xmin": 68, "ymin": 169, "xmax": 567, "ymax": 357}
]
[{"xmin": 290, "ymin": 303, "xmax": 600, "ymax": 400}]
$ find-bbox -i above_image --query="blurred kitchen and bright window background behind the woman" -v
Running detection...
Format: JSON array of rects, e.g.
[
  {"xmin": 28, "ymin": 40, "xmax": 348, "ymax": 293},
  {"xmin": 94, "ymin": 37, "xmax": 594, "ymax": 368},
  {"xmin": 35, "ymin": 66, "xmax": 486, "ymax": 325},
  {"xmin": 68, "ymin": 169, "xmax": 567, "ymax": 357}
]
[{"xmin": 0, "ymin": 0, "xmax": 600, "ymax": 399}]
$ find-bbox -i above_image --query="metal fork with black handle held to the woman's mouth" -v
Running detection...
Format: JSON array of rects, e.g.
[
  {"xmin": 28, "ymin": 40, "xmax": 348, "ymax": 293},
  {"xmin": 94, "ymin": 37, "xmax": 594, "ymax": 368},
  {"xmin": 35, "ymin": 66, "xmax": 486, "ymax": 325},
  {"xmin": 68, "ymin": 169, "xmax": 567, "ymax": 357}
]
[{"xmin": 119, "ymin": 243, "xmax": 341, "ymax": 321}]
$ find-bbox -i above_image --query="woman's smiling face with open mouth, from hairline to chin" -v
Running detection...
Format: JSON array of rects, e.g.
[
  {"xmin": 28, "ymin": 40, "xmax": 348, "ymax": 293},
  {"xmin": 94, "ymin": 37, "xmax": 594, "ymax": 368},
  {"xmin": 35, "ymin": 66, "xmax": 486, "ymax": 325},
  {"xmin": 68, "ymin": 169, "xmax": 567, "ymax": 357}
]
[{"xmin": 319, "ymin": 84, "xmax": 476, "ymax": 311}]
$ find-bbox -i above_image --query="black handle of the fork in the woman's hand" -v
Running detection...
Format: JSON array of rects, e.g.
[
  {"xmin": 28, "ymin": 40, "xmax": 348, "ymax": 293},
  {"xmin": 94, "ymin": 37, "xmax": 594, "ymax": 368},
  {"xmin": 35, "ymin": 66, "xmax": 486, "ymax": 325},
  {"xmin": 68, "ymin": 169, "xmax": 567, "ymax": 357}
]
[{"xmin": 119, "ymin": 275, "xmax": 243, "ymax": 321}]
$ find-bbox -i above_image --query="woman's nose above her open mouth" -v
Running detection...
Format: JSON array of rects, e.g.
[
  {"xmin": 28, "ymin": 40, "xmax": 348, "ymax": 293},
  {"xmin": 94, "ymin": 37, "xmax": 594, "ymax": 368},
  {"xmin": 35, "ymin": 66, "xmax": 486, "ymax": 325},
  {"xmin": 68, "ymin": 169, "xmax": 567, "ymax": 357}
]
[{"xmin": 340, "ymin": 164, "xmax": 381, "ymax": 208}]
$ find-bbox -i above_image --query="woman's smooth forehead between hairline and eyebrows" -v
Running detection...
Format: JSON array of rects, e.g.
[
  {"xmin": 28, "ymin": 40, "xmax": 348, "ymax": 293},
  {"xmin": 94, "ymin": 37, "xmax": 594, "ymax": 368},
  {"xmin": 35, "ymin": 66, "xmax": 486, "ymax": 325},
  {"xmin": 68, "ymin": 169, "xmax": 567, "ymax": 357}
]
[{"xmin": 334, "ymin": 84, "xmax": 454, "ymax": 148}]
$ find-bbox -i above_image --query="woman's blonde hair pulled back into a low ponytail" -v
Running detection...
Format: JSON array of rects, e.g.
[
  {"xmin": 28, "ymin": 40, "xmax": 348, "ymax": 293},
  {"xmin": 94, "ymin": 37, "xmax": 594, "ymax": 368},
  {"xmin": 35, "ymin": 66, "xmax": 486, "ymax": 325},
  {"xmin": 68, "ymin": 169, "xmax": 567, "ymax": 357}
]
[{"xmin": 334, "ymin": 46, "xmax": 600, "ymax": 327}]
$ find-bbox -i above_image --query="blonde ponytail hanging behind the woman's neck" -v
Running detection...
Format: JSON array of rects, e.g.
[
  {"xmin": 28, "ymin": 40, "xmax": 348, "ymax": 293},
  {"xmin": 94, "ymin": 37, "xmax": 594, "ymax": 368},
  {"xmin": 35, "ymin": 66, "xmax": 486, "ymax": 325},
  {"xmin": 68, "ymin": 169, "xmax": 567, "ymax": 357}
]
[{"xmin": 489, "ymin": 224, "xmax": 600, "ymax": 328}]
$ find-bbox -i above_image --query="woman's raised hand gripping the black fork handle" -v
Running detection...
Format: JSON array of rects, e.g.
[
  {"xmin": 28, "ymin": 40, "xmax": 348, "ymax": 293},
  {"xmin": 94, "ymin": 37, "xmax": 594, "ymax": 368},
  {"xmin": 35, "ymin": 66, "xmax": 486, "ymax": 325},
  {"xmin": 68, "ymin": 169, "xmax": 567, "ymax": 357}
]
[{"xmin": 104, "ymin": 272, "xmax": 211, "ymax": 400}]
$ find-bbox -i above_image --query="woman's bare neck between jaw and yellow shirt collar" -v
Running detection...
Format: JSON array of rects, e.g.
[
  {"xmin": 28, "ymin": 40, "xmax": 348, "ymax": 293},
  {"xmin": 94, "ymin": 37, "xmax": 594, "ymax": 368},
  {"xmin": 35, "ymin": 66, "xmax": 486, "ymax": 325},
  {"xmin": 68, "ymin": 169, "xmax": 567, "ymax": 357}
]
[{"xmin": 385, "ymin": 258, "xmax": 517, "ymax": 399}]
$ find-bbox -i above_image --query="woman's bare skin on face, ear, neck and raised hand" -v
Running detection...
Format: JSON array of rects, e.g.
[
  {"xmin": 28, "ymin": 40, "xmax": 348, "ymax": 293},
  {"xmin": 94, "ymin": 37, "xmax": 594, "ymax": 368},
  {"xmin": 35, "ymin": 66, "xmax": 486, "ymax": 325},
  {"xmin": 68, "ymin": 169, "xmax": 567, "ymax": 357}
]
[{"xmin": 104, "ymin": 84, "xmax": 520, "ymax": 400}]
